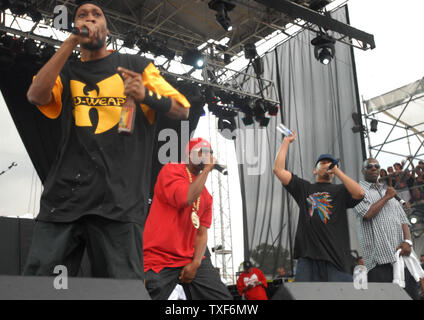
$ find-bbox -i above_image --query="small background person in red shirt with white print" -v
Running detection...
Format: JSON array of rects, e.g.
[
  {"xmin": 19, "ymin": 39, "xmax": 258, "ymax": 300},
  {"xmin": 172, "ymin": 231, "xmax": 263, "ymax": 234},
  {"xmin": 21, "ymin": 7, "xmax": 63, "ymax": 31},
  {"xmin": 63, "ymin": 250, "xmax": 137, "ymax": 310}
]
[{"xmin": 237, "ymin": 261, "xmax": 268, "ymax": 300}]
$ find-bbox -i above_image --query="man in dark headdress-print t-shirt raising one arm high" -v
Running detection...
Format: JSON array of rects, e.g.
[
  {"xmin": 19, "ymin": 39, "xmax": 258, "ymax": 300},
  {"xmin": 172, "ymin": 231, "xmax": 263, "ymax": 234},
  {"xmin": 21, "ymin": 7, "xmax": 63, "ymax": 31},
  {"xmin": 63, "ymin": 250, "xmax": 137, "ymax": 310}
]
[{"xmin": 274, "ymin": 134, "xmax": 364, "ymax": 282}]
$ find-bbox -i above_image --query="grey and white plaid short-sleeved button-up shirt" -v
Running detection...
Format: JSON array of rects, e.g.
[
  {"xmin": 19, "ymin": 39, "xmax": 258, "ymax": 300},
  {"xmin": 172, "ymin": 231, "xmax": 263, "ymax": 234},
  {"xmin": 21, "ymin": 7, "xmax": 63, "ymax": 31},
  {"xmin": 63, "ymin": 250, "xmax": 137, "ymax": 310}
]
[{"xmin": 354, "ymin": 181, "xmax": 409, "ymax": 271}]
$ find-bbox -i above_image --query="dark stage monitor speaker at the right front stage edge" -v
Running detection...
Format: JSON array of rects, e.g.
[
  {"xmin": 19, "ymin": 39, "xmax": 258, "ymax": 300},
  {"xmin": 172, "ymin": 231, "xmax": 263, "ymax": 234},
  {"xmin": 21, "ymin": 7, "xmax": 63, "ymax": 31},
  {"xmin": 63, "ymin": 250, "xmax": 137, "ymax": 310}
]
[{"xmin": 272, "ymin": 282, "xmax": 411, "ymax": 300}]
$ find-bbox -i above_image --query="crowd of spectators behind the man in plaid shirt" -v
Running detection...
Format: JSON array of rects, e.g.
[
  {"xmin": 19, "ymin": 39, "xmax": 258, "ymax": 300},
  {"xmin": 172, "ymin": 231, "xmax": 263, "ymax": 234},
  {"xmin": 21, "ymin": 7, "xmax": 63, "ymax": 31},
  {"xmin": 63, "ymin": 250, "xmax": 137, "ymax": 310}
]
[{"xmin": 379, "ymin": 157, "xmax": 424, "ymax": 208}]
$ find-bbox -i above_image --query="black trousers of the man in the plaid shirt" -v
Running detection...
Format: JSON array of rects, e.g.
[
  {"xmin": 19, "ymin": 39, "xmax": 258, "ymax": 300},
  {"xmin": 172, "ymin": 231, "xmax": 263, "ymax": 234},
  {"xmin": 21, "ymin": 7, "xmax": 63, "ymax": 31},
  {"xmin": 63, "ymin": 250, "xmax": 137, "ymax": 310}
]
[{"xmin": 368, "ymin": 263, "xmax": 420, "ymax": 300}]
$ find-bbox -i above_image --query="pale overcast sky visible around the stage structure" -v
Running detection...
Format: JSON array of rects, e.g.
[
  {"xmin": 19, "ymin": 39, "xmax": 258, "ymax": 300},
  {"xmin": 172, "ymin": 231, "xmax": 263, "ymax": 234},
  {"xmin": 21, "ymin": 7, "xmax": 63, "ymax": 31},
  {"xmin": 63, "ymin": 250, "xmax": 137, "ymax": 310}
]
[{"xmin": 0, "ymin": 0, "xmax": 424, "ymax": 280}]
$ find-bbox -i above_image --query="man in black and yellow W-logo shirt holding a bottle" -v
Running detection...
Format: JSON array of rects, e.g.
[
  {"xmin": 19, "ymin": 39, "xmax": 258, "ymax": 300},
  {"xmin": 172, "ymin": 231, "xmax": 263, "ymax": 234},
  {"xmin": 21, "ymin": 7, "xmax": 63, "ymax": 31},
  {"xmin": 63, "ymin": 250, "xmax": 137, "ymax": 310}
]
[{"xmin": 24, "ymin": 1, "xmax": 190, "ymax": 279}]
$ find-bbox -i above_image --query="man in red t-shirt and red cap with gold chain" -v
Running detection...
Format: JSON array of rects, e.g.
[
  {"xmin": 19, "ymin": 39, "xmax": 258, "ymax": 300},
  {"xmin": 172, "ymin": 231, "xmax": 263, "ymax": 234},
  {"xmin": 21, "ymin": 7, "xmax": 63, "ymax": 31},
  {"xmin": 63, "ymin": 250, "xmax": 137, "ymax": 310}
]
[{"xmin": 143, "ymin": 138, "xmax": 232, "ymax": 300}]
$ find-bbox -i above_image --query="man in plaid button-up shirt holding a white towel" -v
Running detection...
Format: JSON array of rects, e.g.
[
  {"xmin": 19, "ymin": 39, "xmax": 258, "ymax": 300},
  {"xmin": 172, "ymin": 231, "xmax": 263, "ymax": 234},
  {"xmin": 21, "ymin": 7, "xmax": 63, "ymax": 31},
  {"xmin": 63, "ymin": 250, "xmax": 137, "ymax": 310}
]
[{"xmin": 355, "ymin": 158, "xmax": 424, "ymax": 299}]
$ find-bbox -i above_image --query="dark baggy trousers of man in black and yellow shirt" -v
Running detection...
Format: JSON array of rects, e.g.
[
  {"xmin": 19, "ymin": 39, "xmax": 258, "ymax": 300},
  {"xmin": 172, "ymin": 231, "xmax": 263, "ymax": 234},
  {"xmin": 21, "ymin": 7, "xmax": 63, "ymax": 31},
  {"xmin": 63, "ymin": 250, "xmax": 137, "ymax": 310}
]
[{"xmin": 23, "ymin": 215, "xmax": 144, "ymax": 280}]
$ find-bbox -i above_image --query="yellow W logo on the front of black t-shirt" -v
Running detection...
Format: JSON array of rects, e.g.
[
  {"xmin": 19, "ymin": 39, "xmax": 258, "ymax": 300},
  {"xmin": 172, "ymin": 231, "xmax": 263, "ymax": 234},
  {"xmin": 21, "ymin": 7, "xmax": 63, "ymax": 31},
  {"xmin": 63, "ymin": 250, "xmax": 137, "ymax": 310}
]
[{"xmin": 70, "ymin": 74, "xmax": 125, "ymax": 134}]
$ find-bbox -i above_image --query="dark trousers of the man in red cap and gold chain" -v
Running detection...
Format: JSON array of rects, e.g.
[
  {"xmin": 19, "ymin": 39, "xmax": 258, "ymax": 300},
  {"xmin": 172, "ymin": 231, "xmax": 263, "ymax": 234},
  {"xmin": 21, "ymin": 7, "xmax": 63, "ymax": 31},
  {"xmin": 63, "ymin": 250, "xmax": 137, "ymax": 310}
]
[{"xmin": 146, "ymin": 257, "xmax": 233, "ymax": 300}]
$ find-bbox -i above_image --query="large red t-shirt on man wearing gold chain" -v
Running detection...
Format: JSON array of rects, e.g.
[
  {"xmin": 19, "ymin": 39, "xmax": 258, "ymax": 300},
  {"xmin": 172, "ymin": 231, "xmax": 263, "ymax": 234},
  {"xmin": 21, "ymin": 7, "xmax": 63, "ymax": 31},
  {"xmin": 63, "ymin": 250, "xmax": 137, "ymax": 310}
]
[{"xmin": 143, "ymin": 163, "xmax": 212, "ymax": 273}]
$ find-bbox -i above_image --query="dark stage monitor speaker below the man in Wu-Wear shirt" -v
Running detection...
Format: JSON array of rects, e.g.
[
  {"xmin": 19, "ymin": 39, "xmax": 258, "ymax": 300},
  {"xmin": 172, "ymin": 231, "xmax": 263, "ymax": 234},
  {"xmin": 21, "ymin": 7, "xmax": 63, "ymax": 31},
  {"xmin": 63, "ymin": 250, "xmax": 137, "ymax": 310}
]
[{"xmin": 0, "ymin": 276, "xmax": 151, "ymax": 300}]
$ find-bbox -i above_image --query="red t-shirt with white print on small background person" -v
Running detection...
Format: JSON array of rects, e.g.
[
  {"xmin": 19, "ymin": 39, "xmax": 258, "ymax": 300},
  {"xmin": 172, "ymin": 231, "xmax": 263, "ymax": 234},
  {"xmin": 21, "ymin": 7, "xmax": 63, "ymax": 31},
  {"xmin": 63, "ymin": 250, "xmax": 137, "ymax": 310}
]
[{"xmin": 237, "ymin": 268, "xmax": 268, "ymax": 300}]
